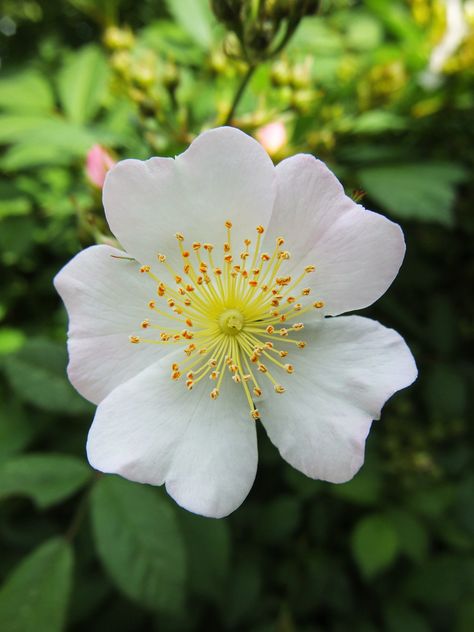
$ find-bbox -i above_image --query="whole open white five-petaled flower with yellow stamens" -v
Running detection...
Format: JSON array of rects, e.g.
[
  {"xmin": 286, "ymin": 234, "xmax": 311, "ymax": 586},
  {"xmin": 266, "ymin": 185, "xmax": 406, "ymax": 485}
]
[{"xmin": 55, "ymin": 128, "xmax": 416, "ymax": 517}]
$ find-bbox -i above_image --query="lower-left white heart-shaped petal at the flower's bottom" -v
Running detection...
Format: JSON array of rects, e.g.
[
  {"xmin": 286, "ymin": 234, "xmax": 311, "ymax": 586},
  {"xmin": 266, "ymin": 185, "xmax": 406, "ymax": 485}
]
[{"xmin": 87, "ymin": 361, "xmax": 257, "ymax": 518}]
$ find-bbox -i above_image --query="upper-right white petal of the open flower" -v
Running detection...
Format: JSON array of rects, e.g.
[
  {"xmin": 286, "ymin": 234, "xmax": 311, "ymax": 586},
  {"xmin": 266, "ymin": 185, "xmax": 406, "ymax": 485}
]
[{"xmin": 266, "ymin": 154, "xmax": 405, "ymax": 315}]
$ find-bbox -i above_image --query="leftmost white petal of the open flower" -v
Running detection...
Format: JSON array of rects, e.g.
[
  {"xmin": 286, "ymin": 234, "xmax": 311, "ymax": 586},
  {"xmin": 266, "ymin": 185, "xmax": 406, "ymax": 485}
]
[{"xmin": 54, "ymin": 246, "xmax": 165, "ymax": 404}]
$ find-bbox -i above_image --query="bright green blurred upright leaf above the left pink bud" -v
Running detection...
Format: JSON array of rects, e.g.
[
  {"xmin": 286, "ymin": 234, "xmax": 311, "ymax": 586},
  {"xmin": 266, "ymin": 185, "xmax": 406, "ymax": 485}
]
[{"xmin": 58, "ymin": 45, "xmax": 108, "ymax": 124}]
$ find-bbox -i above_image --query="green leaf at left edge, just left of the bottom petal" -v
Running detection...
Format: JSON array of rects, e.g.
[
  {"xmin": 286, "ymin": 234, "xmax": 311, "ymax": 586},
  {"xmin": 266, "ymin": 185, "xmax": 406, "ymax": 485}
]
[{"xmin": 0, "ymin": 454, "xmax": 92, "ymax": 509}]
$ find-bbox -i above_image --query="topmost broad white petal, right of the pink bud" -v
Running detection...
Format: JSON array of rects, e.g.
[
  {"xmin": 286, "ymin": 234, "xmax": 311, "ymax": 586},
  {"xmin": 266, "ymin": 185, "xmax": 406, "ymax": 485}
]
[{"xmin": 104, "ymin": 127, "xmax": 275, "ymax": 267}]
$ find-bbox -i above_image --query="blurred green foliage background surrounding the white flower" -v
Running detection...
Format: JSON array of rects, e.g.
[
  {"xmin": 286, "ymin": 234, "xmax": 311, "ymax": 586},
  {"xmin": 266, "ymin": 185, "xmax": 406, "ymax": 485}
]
[{"xmin": 0, "ymin": 0, "xmax": 474, "ymax": 632}]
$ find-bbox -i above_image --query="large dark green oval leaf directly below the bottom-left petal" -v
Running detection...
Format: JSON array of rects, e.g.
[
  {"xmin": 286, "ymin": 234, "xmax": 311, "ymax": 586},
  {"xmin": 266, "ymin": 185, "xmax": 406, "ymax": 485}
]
[{"xmin": 91, "ymin": 476, "xmax": 186, "ymax": 611}]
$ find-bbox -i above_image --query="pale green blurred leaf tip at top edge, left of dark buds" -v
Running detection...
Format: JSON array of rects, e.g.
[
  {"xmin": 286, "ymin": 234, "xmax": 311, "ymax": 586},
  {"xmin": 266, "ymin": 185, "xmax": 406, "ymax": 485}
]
[{"xmin": 165, "ymin": 0, "xmax": 214, "ymax": 49}]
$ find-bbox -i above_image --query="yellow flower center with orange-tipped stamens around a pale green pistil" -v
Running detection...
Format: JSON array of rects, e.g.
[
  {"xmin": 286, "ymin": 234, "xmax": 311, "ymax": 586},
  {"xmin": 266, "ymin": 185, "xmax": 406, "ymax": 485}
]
[{"xmin": 129, "ymin": 221, "xmax": 324, "ymax": 419}]
